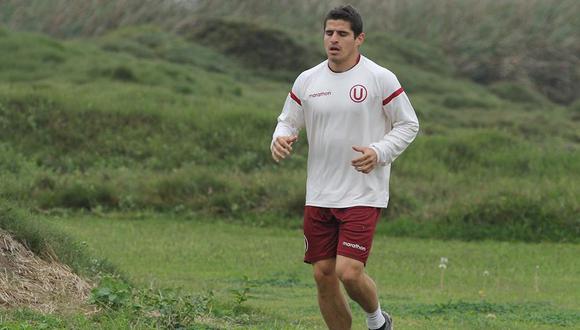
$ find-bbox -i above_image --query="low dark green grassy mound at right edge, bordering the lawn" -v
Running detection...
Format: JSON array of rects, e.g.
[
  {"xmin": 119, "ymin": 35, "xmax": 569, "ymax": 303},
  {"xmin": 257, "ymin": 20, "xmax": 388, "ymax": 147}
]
[{"xmin": 435, "ymin": 190, "xmax": 580, "ymax": 242}]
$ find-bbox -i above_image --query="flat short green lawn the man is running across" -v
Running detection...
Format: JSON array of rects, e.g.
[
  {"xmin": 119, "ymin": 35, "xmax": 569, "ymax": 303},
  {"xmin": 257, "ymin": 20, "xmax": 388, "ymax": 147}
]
[{"xmin": 38, "ymin": 215, "xmax": 580, "ymax": 329}]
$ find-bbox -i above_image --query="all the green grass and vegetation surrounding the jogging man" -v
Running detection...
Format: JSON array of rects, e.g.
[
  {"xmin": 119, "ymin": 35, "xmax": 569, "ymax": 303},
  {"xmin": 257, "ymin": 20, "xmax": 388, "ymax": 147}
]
[{"xmin": 0, "ymin": 0, "xmax": 580, "ymax": 329}]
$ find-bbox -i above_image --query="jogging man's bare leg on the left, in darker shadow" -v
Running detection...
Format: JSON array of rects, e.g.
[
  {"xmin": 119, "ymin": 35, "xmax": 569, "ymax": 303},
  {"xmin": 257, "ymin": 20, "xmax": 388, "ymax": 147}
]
[{"xmin": 314, "ymin": 256, "xmax": 352, "ymax": 330}]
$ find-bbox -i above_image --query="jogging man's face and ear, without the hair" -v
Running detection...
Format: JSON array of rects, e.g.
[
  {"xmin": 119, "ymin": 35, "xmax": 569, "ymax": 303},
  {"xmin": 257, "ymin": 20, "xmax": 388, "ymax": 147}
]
[{"xmin": 324, "ymin": 19, "xmax": 364, "ymax": 63}]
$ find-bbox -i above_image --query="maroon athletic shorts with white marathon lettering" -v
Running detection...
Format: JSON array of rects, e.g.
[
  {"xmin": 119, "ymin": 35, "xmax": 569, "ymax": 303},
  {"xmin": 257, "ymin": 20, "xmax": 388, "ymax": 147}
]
[{"xmin": 304, "ymin": 206, "xmax": 381, "ymax": 264}]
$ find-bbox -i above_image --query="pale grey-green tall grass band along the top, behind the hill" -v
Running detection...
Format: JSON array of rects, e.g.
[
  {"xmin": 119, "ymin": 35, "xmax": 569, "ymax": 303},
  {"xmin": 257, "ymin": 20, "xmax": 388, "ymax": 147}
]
[{"xmin": 0, "ymin": 0, "xmax": 580, "ymax": 103}]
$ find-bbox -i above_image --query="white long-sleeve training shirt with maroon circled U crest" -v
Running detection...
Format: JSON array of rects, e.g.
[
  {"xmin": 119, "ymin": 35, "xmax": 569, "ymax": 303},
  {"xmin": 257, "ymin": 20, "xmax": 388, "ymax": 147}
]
[{"xmin": 272, "ymin": 56, "xmax": 419, "ymax": 208}]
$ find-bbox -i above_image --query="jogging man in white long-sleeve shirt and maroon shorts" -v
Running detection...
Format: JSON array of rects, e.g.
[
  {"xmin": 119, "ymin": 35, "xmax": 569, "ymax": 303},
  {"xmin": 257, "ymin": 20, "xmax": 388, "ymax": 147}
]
[{"xmin": 271, "ymin": 6, "xmax": 419, "ymax": 330}]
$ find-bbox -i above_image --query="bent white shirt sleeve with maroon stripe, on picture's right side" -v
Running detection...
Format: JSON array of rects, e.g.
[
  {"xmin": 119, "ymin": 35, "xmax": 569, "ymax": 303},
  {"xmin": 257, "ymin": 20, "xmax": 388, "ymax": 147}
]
[{"xmin": 370, "ymin": 72, "xmax": 419, "ymax": 166}]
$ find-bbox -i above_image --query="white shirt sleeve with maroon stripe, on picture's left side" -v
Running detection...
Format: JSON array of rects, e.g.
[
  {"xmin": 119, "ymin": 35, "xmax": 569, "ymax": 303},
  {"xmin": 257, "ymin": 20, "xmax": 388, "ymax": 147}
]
[{"xmin": 270, "ymin": 77, "xmax": 304, "ymax": 149}]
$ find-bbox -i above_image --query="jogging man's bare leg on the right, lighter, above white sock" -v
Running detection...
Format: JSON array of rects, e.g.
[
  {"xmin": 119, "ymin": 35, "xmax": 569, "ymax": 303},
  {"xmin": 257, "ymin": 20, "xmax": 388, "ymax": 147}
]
[{"xmin": 336, "ymin": 255, "xmax": 379, "ymax": 313}]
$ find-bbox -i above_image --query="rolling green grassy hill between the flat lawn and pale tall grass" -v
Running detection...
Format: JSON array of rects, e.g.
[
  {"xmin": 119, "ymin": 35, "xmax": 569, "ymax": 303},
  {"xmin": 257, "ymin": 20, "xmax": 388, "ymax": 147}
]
[{"xmin": 0, "ymin": 22, "xmax": 580, "ymax": 240}]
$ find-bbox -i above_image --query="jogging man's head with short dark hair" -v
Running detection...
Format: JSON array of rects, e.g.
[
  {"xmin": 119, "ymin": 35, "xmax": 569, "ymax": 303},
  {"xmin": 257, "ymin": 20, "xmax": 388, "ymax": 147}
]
[{"xmin": 324, "ymin": 5, "xmax": 365, "ymax": 66}]
